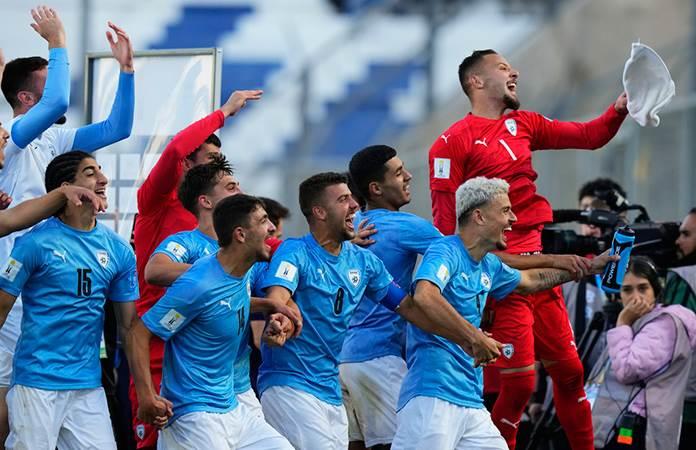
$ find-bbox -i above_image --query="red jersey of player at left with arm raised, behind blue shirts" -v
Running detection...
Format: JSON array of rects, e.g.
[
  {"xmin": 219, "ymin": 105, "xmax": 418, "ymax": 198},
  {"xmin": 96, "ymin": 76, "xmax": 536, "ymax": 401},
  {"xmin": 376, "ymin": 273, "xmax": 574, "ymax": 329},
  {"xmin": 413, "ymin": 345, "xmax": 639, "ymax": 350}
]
[{"xmin": 134, "ymin": 110, "xmax": 225, "ymax": 316}]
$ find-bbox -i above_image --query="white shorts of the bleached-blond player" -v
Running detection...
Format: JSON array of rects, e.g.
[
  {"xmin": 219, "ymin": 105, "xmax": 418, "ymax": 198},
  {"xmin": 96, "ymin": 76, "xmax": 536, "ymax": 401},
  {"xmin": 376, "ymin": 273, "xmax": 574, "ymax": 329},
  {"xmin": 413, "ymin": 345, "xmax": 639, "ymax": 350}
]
[{"xmin": 391, "ymin": 397, "xmax": 508, "ymax": 450}]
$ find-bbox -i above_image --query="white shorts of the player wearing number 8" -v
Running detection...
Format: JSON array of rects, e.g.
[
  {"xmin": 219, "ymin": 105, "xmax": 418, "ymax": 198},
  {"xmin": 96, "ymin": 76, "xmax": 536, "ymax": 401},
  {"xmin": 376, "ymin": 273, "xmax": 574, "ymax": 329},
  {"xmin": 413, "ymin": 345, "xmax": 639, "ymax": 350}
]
[{"xmin": 261, "ymin": 386, "xmax": 348, "ymax": 450}]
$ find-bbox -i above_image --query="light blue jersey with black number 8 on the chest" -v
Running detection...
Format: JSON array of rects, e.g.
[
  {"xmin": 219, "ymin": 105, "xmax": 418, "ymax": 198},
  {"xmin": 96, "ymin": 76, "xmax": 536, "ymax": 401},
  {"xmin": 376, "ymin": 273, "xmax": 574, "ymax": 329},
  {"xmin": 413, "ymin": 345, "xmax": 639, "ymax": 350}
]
[{"xmin": 258, "ymin": 233, "xmax": 392, "ymax": 405}]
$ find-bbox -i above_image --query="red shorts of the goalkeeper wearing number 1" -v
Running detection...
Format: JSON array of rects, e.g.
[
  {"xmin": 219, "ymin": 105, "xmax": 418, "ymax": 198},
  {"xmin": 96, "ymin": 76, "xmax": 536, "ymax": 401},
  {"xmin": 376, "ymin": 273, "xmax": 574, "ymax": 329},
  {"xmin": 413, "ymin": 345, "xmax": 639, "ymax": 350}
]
[{"xmin": 487, "ymin": 286, "xmax": 578, "ymax": 369}]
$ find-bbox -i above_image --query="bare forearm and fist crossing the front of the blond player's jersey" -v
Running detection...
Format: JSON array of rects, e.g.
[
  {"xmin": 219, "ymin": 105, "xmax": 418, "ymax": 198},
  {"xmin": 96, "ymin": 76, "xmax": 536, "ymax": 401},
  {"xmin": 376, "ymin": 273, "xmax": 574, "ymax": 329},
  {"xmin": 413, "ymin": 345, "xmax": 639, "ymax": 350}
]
[{"xmin": 396, "ymin": 280, "xmax": 502, "ymax": 366}]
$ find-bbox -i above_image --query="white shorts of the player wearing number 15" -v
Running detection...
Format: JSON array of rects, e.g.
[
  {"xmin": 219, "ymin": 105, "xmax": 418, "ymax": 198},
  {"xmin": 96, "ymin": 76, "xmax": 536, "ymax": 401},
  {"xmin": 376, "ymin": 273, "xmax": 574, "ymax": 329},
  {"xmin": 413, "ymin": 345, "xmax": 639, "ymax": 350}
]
[{"xmin": 5, "ymin": 385, "xmax": 116, "ymax": 450}]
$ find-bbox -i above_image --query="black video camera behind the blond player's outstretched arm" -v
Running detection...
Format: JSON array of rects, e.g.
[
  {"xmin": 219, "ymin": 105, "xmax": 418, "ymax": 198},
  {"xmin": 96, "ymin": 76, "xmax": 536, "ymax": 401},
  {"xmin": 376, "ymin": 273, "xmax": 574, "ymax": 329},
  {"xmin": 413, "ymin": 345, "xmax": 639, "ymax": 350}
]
[{"xmin": 541, "ymin": 201, "xmax": 679, "ymax": 268}]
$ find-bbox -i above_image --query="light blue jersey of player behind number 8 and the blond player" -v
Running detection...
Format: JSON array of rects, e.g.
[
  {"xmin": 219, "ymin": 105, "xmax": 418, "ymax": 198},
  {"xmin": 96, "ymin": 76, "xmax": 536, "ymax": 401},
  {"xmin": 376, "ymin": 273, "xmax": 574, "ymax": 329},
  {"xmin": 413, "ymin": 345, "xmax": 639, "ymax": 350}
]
[{"xmin": 341, "ymin": 209, "xmax": 442, "ymax": 363}]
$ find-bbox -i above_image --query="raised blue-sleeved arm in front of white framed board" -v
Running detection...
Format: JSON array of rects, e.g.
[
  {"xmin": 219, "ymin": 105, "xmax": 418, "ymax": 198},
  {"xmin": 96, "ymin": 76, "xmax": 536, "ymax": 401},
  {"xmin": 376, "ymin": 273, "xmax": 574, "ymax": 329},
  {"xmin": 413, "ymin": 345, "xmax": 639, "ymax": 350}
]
[{"xmin": 73, "ymin": 22, "xmax": 135, "ymax": 152}]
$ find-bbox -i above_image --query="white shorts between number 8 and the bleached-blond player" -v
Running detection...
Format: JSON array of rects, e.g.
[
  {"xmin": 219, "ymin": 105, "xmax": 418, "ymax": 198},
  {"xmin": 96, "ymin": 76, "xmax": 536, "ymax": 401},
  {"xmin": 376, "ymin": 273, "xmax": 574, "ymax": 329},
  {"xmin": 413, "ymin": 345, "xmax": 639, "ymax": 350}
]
[{"xmin": 338, "ymin": 356, "xmax": 408, "ymax": 447}]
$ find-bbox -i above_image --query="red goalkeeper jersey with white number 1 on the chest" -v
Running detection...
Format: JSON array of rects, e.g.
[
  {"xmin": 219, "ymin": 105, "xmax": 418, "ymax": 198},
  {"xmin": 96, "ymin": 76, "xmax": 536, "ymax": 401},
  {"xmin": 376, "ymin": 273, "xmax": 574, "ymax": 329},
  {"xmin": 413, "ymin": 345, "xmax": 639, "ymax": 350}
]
[{"xmin": 428, "ymin": 105, "xmax": 625, "ymax": 251}]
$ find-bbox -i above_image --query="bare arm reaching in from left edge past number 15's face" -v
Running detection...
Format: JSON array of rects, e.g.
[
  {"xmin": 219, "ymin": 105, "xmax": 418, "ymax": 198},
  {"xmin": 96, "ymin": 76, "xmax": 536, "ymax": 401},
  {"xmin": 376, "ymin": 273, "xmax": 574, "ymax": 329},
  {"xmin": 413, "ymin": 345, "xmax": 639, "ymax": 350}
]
[{"xmin": 0, "ymin": 186, "xmax": 105, "ymax": 236}]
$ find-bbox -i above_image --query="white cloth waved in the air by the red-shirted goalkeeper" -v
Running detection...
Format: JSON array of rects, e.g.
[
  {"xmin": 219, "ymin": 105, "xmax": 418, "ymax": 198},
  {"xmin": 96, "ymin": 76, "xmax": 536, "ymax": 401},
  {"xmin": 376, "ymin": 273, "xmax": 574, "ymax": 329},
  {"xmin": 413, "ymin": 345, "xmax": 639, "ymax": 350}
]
[{"xmin": 623, "ymin": 42, "xmax": 674, "ymax": 127}]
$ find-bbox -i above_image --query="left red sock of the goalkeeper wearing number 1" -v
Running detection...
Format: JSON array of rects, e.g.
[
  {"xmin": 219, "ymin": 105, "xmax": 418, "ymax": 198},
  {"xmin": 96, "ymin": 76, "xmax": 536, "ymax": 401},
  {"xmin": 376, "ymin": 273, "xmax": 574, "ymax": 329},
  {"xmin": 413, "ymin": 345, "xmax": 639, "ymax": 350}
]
[{"xmin": 491, "ymin": 370, "xmax": 535, "ymax": 450}]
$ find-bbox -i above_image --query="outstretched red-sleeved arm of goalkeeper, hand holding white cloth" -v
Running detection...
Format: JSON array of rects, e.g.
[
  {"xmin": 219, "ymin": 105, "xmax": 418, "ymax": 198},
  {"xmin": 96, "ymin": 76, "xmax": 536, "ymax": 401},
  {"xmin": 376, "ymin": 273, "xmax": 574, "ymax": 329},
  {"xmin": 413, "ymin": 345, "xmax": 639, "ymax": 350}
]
[{"xmin": 532, "ymin": 93, "xmax": 628, "ymax": 150}]
